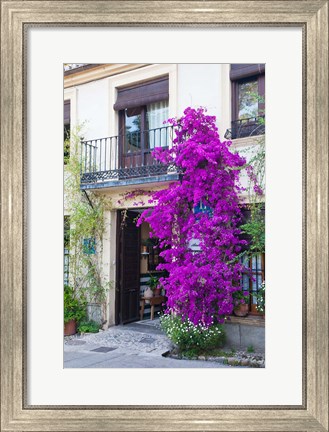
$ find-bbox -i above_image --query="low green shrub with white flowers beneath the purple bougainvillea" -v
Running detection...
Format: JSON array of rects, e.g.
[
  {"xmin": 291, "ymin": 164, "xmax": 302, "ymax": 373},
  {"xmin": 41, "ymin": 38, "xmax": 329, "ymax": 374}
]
[{"xmin": 160, "ymin": 315, "xmax": 225, "ymax": 355}]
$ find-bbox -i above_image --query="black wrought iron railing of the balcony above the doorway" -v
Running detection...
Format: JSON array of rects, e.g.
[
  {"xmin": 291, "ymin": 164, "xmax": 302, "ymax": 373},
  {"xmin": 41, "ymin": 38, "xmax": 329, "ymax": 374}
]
[{"xmin": 81, "ymin": 126, "xmax": 175, "ymax": 184}]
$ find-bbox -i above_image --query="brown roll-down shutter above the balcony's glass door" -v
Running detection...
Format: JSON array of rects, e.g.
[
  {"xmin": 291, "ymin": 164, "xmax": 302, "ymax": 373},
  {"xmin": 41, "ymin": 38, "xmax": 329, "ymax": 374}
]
[{"xmin": 113, "ymin": 76, "xmax": 169, "ymax": 111}]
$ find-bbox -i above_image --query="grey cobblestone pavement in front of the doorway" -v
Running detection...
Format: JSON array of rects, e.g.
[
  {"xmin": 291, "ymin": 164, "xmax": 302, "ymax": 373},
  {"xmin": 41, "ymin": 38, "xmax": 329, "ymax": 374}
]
[{"xmin": 64, "ymin": 319, "xmax": 230, "ymax": 368}]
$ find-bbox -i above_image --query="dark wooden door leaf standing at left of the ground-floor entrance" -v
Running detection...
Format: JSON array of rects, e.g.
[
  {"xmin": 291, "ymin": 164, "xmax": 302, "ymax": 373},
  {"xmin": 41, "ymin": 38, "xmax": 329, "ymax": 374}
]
[{"xmin": 116, "ymin": 211, "xmax": 140, "ymax": 324}]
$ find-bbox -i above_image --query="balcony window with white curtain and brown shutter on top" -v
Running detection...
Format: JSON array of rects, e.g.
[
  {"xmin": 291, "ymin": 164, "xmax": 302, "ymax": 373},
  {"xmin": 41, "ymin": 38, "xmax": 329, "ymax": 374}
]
[{"xmin": 114, "ymin": 76, "xmax": 170, "ymax": 168}]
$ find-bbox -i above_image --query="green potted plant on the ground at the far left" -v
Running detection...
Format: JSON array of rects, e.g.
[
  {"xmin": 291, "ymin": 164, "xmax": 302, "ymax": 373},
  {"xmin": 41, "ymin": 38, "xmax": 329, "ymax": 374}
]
[{"xmin": 64, "ymin": 285, "xmax": 87, "ymax": 336}]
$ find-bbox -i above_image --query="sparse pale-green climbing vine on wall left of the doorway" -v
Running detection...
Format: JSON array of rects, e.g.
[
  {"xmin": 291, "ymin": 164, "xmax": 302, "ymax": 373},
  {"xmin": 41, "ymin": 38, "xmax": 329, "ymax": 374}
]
[{"xmin": 64, "ymin": 127, "xmax": 111, "ymax": 304}]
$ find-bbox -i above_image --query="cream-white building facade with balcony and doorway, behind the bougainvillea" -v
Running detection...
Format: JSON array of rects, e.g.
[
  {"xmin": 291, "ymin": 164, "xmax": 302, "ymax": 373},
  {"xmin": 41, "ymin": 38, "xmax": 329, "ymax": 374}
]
[{"xmin": 64, "ymin": 64, "xmax": 265, "ymax": 327}]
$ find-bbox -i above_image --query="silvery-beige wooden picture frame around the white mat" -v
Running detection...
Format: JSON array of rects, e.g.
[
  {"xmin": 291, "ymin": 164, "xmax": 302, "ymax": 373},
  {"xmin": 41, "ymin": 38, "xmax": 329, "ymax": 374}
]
[{"xmin": 1, "ymin": 0, "xmax": 329, "ymax": 432}]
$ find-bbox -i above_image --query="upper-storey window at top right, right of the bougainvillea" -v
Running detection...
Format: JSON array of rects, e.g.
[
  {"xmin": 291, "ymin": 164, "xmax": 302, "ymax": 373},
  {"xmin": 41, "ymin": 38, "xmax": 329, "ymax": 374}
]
[{"xmin": 230, "ymin": 64, "xmax": 265, "ymax": 139}]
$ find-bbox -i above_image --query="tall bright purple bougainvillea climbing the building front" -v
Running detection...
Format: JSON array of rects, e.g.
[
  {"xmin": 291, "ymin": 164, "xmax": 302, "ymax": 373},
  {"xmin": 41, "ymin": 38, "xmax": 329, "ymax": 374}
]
[{"xmin": 138, "ymin": 107, "xmax": 246, "ymax": 327}]
